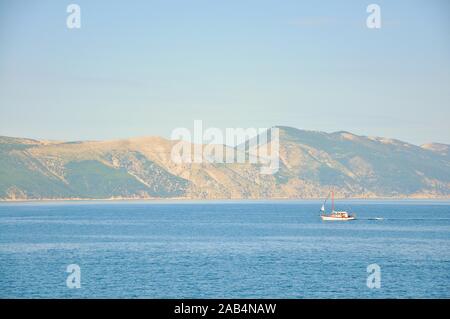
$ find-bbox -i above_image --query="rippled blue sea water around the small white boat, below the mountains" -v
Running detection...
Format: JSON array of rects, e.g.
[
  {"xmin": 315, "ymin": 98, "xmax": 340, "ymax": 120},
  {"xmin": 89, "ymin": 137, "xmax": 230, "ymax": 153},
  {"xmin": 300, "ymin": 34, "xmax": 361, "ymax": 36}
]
[{"xmin": 0, "ymin": 201, "xmax": 450, "ymax": 298}]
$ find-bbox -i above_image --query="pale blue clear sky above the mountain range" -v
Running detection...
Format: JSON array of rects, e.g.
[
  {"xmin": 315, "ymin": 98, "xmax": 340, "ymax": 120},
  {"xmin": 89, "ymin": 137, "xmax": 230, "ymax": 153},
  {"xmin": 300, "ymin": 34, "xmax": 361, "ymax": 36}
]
[{"xmin": 0, "ymin": 0, "xmax": 450, "ymax": 144}]
